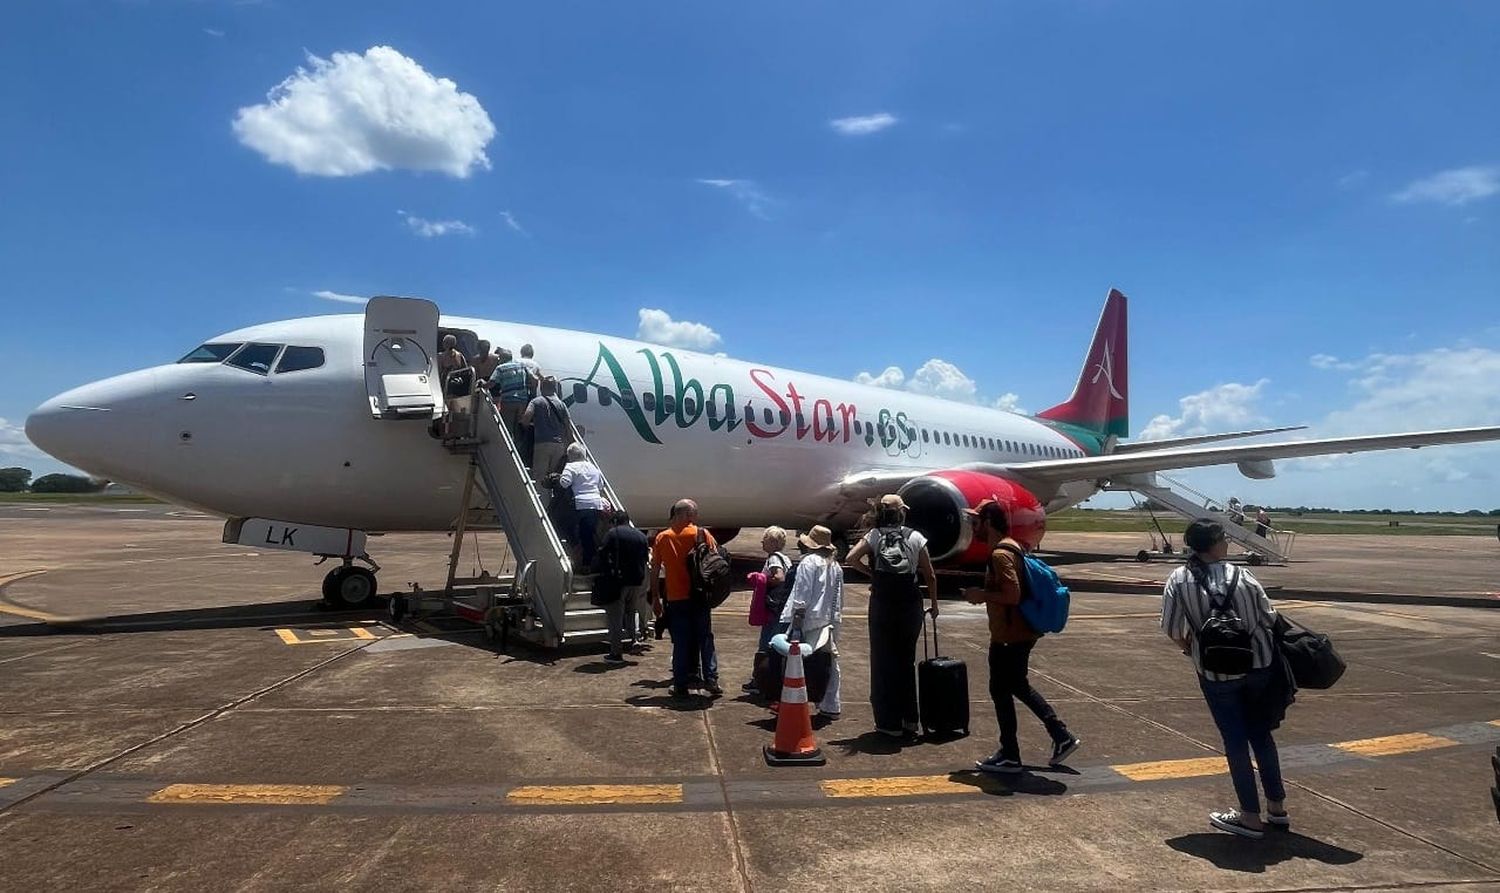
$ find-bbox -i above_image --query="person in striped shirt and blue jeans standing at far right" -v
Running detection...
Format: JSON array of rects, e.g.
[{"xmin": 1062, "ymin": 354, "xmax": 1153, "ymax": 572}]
[{"xmin": 1161, "ymin": 519, "xmax": 1290, "ymax": 839}]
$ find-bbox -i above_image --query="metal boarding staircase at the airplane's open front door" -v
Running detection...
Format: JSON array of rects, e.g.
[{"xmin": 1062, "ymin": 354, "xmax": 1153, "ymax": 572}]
[{"xmin": 429, "ymin": 399, "xmax": 621, "ymax": 647}]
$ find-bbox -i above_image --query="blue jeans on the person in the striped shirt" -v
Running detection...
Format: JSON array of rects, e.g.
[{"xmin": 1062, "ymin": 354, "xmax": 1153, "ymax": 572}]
[{"xmin": 1199, "ymin": 668, "xmax": 1287, "ymax": 815}]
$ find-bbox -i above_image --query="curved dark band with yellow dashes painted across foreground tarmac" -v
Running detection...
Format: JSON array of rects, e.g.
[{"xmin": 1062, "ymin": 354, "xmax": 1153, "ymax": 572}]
[{"xmin": 0, "ymin": 719, "xmax": 1500, "ymax": 815}]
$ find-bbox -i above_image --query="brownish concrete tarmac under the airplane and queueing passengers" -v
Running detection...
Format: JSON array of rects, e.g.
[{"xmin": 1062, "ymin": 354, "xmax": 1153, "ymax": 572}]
[{"xmin": 0, "ymin": 507, "xmax": 1500, "ymax": 890}]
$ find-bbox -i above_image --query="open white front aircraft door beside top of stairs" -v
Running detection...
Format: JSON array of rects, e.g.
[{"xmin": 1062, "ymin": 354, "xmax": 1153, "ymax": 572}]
[{"xmin": 365, "ymin": 297, "xmax": 443, "ymax": 419}]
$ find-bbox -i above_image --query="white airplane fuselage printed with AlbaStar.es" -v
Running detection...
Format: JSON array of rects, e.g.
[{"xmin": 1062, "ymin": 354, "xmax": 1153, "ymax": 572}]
[{"xmin": 23, "ymin": 315, "xmax": 1100, "ymax": 531}]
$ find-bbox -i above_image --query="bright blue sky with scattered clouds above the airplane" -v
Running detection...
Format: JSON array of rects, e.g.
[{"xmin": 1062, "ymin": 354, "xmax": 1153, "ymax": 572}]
[{"xmin": 0, "ymin": 0, "xmax": 1500, "ymax": 509}]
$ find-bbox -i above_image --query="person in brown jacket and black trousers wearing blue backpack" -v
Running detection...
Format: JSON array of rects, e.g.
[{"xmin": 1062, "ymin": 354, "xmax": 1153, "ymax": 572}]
[{"xmin": 965, "ymin": 500, "xmax": 1083, "ymax": 774}]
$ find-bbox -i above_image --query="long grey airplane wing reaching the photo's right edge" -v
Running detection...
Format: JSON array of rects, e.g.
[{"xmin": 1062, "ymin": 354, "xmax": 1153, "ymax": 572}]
[{"xmin": 965, "ymin": 426, "xmax": 1500, "ymax": 483}]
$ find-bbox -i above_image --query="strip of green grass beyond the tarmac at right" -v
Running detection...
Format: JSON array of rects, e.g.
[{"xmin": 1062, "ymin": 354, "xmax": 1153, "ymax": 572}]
[{"xmin": 1047, "ymin": 509, "xmax": 1500, "ymax": 537}]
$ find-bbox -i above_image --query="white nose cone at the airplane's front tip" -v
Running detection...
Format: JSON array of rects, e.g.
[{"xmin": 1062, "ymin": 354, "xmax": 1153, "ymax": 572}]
[{"xmin": 26, "ymin": 369, "xmax": 158, "ymax": 483}]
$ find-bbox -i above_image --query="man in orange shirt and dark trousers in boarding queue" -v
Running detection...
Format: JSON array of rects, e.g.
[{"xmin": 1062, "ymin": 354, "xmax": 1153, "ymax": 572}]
[{"xmin": 647, "ymin": 500, "xmax": 725, "ymax": 698}]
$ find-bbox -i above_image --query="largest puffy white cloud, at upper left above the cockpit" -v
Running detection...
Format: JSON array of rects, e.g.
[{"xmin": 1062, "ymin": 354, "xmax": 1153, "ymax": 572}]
[{"xmin": 234, "ymin": 47, "xmax": 495, "ymax": 177}]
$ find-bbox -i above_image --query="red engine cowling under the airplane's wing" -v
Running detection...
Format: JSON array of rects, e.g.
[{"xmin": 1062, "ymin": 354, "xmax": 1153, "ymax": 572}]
[{"xmin": 899, "ymin": 470, "xmax": 1047, "ymax": 564}]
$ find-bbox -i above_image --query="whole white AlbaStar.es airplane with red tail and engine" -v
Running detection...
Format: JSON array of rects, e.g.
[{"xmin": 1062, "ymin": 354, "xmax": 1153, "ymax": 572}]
[{"xmin": 26, "ymin": 290, "xmax": 1500, "ymax": 600}]
